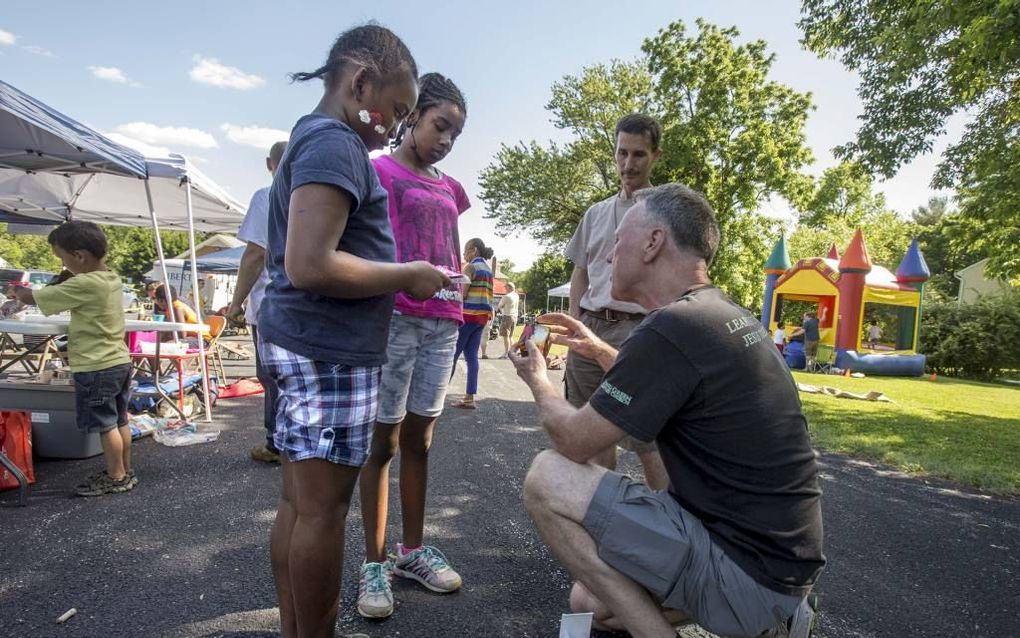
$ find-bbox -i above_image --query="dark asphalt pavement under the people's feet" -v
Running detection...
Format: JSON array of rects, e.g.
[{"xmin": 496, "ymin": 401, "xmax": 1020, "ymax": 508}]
[{"xmin": 0, "ymin": 336, "xmax": 1020, "ymax": 638}]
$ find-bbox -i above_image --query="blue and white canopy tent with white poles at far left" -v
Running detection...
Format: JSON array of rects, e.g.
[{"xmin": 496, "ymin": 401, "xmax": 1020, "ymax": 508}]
[{"xmin": 0, "ymin": 82, "xmax": 245, "ymax": 422}]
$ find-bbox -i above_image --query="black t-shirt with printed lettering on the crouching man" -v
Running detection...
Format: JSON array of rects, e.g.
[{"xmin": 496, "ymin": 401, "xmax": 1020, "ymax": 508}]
[{"xmin": 591, "ymin": 287, "xmax": 825, "ymax": 595}]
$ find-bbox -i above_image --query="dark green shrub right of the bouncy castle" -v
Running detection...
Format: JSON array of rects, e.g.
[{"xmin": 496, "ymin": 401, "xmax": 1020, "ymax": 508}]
[{"xmin": 920, "ymin": 291, "xmax": 1020, "ymax": 379}]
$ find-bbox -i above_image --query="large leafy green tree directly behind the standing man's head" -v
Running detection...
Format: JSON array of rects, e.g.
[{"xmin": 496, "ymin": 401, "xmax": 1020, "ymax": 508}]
[{"xmin": 479, "ymin": 20, "xmax": 812, "ymax": 307}]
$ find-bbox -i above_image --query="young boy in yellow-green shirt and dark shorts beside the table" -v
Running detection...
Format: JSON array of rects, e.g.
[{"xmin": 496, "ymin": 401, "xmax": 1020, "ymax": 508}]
[{"xmin": 15, "ymin": 222, "xmax": 138, "ymax": 496}]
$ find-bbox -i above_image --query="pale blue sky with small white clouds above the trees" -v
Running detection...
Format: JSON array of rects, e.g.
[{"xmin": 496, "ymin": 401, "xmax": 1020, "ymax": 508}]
[{"xmin": 0, "ymin": 0, "xmax": 959, "ymax": 265}]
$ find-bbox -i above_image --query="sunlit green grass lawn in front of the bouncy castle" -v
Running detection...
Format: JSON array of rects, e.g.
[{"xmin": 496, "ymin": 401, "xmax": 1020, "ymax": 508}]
[{"xmin": 794, "ymin": 373, "xmax": 1020, "ymax": 493}]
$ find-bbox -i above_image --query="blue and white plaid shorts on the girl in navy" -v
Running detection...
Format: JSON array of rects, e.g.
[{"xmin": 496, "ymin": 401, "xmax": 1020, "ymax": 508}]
[{"xmin": 258, "ymin": 339, "xmax": 381, "ymax": 468}]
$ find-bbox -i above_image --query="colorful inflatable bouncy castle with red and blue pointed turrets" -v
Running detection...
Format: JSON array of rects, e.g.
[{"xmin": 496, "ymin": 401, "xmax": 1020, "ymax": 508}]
[{"xmin": 761, "ymin": 229, "xmax": 930, "ymax": 377}]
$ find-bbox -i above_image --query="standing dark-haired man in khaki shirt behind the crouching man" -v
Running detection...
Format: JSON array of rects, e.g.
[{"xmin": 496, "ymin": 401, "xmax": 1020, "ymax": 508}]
[{"xmin": 564, "ymin": 113, "xmax": 669, "ymax": 490}]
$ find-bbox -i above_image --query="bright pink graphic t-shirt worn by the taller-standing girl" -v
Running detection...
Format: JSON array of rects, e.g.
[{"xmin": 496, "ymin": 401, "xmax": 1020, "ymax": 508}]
[{"xmin": 372, "ymin": 155, "xmax": 471, "ymax": 324}]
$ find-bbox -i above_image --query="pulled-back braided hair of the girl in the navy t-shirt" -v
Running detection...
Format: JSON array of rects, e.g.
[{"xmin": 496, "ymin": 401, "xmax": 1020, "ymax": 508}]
[{"xmin": 291, "ymin": 22, "xmax": 418, "ymax": 88}]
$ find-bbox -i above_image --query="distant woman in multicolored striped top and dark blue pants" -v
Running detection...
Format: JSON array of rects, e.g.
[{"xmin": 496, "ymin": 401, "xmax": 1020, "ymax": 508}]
[{"xmin": 453, "ymin": 238, "xmax": 493, "ymax": 409}]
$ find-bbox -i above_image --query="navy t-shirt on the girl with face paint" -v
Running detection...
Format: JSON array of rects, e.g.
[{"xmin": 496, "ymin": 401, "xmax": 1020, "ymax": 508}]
[{"xmin": 258, "ymin": 113, "xmax": 397, "ymax": 365}]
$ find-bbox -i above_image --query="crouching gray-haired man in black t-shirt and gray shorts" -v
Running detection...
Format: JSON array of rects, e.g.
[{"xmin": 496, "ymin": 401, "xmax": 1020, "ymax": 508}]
[{"xmin": 512, "ymin": 184, "xmax": 825, "ymax": 638}]
